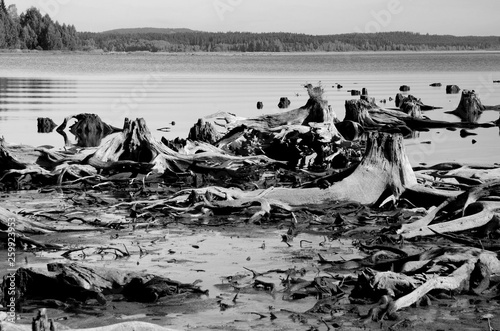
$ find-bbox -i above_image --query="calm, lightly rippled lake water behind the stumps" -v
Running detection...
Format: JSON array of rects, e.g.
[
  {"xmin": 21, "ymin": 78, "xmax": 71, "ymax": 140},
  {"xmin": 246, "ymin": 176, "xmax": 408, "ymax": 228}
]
[{"xmin": 0, "ymin": 52, "xmax": 500, "ymax": 165}]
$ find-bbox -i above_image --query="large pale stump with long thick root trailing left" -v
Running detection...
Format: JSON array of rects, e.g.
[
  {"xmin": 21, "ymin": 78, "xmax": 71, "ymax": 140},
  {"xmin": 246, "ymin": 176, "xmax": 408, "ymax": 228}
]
[{"xmin": 169, "ymin": 133, "xmax": 417, "ymax": 221}]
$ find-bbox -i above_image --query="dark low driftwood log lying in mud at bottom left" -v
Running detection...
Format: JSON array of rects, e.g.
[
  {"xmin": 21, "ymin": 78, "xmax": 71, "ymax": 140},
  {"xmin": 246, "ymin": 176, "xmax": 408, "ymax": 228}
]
[{"xmin": 4, "ymin": 263, "xmax": 208, "ymax": 308}]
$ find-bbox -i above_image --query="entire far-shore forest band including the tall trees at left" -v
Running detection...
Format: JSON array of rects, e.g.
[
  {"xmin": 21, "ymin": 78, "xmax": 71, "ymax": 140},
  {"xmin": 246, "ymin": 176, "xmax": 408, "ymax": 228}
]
[{"xmin": 0, "ymin": 0, "xmax": 500, "ymax": 52}]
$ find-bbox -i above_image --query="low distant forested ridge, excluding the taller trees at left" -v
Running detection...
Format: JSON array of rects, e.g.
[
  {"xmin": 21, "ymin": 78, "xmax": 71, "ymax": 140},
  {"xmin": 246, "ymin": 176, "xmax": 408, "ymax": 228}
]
[{"xmin": 79, "ymin": 31, "xmax": 500, "ymax": 52}]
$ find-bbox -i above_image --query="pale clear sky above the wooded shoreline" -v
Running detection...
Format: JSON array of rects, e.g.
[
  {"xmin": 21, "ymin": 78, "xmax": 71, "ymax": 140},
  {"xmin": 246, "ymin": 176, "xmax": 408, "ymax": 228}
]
[{"xmin": 9, "ymin": 0, "xmax": 500, "ymax": 36}]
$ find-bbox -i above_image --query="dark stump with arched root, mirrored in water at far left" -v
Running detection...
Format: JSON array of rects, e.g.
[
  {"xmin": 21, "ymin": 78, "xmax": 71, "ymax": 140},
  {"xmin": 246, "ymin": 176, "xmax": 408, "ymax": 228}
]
[{"xmin": 57, "ymin": 113, "xmax": 120, "ymax": 147}]
